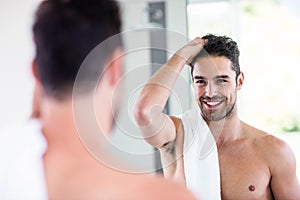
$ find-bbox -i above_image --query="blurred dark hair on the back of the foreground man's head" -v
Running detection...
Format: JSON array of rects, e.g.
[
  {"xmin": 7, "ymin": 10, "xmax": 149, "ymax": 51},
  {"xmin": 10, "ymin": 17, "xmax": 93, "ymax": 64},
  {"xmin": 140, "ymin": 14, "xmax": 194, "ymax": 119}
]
[{"xmin": 33, "ymin": 0, "xmax": 122, "ymax": 99}]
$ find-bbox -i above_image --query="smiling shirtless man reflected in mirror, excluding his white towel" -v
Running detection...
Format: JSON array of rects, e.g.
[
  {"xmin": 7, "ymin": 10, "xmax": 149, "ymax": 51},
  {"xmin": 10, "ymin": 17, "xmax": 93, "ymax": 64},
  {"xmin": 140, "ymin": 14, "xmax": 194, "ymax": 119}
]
[{"xmin": 134, "ymin": 35, "xmax": 300, "ymax": 200}]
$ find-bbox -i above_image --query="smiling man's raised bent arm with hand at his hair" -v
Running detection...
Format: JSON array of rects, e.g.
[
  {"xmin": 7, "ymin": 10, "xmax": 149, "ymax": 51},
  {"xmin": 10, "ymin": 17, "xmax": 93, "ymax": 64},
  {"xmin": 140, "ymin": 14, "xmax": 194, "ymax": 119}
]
[{"xmin": 134, "ymin": 37, "xmax": 205, "ymax": 148}]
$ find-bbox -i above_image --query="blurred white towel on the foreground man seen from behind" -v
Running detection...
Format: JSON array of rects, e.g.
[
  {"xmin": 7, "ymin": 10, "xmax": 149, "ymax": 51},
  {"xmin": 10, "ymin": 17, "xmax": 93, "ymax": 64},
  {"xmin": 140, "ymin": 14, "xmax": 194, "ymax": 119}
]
[{"xmin": 0, "ymin": 120, "xmax": 48, "ymax": 200}]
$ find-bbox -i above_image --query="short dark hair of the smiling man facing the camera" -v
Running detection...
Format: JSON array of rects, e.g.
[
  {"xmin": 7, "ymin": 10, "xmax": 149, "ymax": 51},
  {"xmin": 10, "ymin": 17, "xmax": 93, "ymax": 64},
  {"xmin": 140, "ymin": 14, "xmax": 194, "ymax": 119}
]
[{"xmin": 191, "ymin": 34, "xmax": 240, "ymax": 79}]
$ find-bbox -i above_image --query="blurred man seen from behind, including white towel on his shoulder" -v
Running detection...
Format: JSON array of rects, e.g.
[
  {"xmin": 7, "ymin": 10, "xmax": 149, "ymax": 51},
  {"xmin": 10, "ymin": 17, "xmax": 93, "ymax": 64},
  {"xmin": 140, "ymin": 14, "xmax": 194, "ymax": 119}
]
[{"xmin": 0, "ymin": 0, "xmax": 194, "ymax": 200}]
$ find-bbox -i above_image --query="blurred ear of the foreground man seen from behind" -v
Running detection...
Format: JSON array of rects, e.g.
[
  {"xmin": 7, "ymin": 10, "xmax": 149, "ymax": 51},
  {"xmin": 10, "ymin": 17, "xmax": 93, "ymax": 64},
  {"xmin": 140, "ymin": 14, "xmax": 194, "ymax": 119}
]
[{"xmin": 106, "ymin": 48, "xmax": 123, "ymax": 86}]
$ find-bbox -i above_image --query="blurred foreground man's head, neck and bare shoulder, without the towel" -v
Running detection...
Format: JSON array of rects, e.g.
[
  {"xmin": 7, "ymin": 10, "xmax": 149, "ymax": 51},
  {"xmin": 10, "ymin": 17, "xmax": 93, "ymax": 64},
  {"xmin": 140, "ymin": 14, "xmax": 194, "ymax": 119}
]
[{"xmin": 32, "ymin": 0, "xmax": 197, "ymax": 199}]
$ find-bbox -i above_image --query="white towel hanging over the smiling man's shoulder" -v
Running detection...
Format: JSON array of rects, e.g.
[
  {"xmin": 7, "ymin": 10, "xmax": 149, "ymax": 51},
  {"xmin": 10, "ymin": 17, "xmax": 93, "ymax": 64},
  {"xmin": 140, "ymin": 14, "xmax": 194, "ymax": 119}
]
[{"xmin": 182, "ymin": 108, "xmax": 221, "ymax": 200}]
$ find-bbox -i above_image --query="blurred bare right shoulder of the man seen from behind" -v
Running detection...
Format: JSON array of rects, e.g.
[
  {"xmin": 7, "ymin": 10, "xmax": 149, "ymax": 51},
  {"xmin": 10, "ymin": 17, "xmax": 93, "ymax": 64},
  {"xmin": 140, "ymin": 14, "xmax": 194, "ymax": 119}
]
[{"xmin": 89, "ymin": 169, "xmax": 195, "ymax": 200}]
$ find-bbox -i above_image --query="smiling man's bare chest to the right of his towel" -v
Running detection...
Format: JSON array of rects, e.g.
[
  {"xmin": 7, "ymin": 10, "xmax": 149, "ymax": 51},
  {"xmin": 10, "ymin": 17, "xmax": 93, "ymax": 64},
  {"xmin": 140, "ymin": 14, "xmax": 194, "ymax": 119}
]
[{"xmin": 219, "ymin": 145, "xmax": 272, "ymax": 200}]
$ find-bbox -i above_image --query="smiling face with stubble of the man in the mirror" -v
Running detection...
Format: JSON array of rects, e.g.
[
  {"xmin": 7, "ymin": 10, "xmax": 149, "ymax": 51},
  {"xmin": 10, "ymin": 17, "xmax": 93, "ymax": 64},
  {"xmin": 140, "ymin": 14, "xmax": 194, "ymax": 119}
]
[{"xmin": 193, "ymin": 56, "xmax": 243, "ymax": 121}]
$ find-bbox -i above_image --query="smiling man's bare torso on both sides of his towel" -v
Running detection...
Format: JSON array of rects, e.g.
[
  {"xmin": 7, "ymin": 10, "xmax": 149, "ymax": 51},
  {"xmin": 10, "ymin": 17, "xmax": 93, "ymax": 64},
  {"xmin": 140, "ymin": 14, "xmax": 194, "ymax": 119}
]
[{"xmin": 160, "ymin": 118, "xmax": 273, "ymax": 199}]
